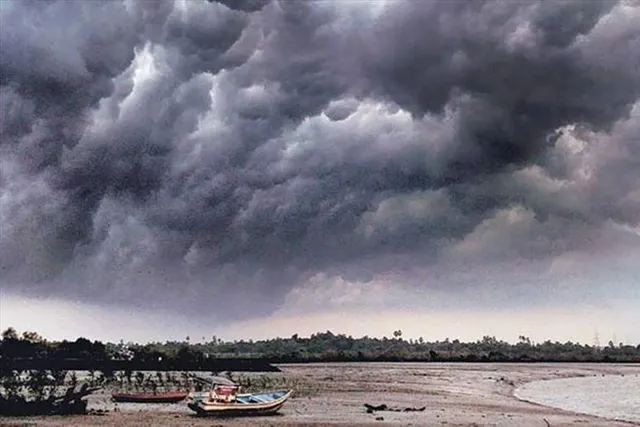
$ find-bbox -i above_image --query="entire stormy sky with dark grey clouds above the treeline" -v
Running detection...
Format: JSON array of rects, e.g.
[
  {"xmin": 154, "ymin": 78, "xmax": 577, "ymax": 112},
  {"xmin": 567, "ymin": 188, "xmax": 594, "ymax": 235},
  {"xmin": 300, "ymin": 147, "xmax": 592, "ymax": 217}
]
[{"xmin": 0, "ymin": 0, "xmax": 640, "ymax": 343}]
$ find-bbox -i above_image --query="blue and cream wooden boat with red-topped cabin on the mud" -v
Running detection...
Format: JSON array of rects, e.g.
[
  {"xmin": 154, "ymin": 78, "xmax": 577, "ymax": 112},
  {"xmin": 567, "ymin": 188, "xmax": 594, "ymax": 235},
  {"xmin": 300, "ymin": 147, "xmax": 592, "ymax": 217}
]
[{"xmin": 187, "ymin": 386, "xmax": 293, "ymax": 417}]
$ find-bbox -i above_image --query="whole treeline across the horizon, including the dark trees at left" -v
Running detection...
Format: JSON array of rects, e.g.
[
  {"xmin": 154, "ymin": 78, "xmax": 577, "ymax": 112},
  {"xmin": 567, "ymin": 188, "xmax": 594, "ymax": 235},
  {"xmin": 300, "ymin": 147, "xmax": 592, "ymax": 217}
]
[{"xmin": 0, "ymin": 328, "xmax": 640, "ymax": 372}]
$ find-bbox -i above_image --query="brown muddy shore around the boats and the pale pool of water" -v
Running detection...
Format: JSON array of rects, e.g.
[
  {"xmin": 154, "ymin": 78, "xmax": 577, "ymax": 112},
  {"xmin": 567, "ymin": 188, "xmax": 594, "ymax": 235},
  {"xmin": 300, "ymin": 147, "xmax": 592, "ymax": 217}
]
[{"xmin": 0, "ymin": 363, "xmax": 640, "ymax": 427}]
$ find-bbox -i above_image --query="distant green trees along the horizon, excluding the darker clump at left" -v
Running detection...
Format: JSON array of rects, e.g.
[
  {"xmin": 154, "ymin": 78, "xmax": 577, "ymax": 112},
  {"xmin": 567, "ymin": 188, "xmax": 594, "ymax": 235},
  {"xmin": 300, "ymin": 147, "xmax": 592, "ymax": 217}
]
[{"xmin": 178, "ymin": 330, "xmax": 640, "ymax": 363}]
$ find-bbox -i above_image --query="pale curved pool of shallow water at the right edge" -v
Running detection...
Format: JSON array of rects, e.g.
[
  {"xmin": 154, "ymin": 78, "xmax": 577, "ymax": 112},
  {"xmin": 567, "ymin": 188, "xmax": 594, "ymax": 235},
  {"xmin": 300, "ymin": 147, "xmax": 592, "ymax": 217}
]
[{"xmin": 515, "ymin": 374, "xmax": 640, "ymax": 422}]
